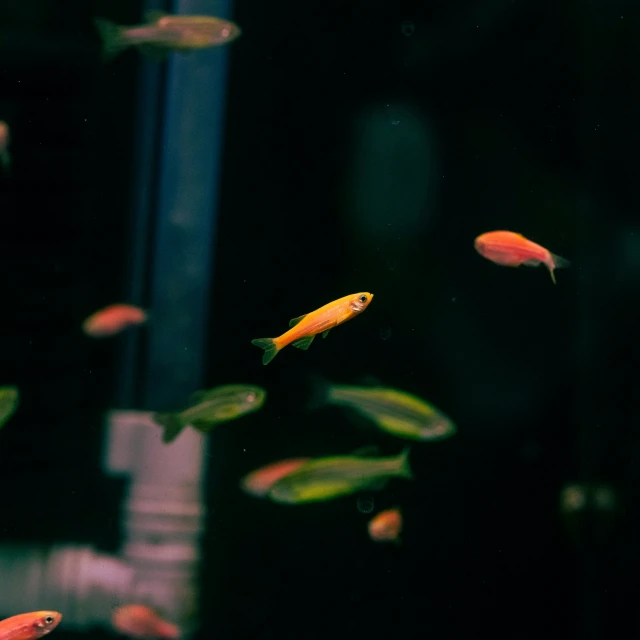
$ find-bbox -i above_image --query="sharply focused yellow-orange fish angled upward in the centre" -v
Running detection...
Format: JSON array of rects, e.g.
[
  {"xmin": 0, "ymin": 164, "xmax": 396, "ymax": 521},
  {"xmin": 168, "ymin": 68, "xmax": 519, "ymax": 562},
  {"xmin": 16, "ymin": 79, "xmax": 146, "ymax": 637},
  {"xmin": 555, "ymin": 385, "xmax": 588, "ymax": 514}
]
[{"xmin": 251, "ymin": 291, "xmax": 373, "ymax": 364}]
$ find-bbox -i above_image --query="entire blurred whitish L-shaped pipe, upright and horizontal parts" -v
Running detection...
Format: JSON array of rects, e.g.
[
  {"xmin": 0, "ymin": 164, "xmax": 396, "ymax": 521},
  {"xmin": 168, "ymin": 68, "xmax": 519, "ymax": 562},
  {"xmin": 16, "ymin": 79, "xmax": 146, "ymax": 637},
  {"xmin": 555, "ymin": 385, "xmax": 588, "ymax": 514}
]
[{"xmin": 0, "ymin": 411, "xmax": 206, "ymax": 633}]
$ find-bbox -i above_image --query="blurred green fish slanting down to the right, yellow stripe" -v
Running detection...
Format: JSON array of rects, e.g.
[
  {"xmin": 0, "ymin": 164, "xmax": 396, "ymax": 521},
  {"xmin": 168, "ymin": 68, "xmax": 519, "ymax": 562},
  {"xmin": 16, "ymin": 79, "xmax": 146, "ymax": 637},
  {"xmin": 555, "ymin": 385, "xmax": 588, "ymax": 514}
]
[{"xmin": 321, "ymin": 383, "xmax": 457, "ymax": 440}]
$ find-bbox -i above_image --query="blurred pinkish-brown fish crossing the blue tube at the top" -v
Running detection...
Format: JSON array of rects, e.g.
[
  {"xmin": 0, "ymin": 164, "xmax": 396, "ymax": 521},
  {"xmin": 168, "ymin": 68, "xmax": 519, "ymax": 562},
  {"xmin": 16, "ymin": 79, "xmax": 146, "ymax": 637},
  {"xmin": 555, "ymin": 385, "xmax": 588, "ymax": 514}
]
[{"xmin": 95, "ymin": 11, "xmax": 242, "ymax": 59}]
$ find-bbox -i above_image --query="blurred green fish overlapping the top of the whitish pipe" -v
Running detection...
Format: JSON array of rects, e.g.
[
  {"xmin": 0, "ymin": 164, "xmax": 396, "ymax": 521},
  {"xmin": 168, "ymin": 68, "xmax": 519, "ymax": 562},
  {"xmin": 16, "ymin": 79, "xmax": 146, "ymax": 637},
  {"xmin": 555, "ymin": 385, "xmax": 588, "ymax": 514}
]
[{"xmin": 153, "ymin": 384, "xmax": 267, "ymax": 443}]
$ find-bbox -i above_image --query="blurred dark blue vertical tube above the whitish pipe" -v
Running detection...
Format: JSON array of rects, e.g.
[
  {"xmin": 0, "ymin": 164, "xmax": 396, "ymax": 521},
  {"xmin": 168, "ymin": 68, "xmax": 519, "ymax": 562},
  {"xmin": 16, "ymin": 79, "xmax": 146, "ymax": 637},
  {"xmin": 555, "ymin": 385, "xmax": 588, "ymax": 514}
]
[{"xmin": 119, "ymin": 0, "xmax": 233, "ymax": 411}]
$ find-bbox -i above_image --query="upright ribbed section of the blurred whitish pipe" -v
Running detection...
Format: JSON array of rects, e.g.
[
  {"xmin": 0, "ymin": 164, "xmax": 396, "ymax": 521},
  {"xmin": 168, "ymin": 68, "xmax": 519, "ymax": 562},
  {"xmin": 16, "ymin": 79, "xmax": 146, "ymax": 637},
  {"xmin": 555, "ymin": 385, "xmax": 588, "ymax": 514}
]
[{"xmin": 105, "ymin": 411, "xmax": 206, "ymax": 626}]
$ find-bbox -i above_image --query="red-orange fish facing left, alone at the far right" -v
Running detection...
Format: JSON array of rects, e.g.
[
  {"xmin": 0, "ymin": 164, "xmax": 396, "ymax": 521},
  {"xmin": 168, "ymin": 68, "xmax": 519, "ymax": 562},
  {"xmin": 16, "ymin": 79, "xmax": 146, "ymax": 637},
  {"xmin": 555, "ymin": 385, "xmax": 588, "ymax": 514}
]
[{"xmin": 475, "ymin": 231, "xmax": 570, "ymax": 284}]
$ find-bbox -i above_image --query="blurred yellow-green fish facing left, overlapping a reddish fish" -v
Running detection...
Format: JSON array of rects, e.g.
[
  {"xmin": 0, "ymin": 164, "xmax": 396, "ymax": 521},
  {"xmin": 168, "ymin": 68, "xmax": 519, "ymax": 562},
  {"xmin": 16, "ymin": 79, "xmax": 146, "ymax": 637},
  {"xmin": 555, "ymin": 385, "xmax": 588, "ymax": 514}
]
[{"xmin": 268, "ymin": 448, "xmax": 413, "ymax": 504}]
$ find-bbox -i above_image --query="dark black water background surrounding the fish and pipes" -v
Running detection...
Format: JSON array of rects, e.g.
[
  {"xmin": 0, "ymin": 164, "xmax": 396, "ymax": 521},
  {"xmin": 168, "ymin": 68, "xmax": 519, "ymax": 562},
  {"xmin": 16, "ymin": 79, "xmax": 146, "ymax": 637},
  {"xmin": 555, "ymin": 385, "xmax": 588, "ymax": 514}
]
[{"xmin": 0, "ymin": 0, "xmax": 640, "ymax": 640}]
